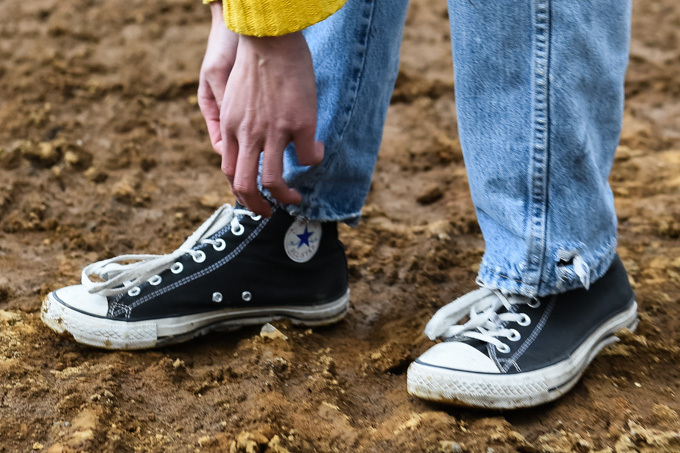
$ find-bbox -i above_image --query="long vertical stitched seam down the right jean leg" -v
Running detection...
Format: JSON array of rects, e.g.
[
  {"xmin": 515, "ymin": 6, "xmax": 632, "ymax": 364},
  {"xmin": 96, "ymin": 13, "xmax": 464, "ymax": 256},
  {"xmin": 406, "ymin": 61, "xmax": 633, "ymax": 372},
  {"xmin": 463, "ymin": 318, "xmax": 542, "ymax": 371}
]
[{"xmin": 527, "ymin": 0, "xmax": 550, "ymax": 287}]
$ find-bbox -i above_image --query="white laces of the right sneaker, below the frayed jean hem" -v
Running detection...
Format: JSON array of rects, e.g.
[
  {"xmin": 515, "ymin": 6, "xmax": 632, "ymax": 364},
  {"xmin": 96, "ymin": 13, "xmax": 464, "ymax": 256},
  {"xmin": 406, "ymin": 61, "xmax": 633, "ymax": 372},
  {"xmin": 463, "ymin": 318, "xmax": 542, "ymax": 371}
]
[{"xmin": 425, "ymin": 288, "xmax": 540, "ymax": 353}]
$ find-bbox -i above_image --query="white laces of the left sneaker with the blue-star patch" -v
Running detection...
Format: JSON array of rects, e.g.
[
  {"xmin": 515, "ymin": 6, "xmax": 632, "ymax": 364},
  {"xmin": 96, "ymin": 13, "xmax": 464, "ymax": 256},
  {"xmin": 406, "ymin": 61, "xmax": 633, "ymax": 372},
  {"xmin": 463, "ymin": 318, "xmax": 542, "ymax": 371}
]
[{"xmin": 81, "ymin": 204, "xmax": 260, "ymax": 296}]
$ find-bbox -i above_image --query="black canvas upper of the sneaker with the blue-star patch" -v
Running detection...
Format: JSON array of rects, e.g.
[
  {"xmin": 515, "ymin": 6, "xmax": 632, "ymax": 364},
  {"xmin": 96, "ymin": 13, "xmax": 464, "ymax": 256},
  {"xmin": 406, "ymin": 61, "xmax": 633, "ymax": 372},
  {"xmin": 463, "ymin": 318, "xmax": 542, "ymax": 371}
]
[{"xmin": 85, "ymin": 209, "xmax": 348, "ymax": 321}]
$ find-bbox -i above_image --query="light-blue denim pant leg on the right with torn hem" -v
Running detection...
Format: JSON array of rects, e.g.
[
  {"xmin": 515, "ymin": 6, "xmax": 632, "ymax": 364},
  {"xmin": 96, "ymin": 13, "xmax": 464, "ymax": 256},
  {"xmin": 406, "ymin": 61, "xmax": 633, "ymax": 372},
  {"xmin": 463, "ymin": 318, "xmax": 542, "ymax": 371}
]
[{"xmin": 449, "ymin": 0, "xmax": 631, "ymax": 296}]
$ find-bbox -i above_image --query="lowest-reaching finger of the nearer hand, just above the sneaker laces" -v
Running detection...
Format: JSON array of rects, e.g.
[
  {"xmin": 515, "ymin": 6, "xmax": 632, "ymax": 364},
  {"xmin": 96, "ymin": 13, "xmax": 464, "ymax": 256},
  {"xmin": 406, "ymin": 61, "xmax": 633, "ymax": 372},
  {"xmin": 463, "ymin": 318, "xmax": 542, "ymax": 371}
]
[{"xmin": 232, "ymin": 142, "xmax": 272, "ymax": 217}]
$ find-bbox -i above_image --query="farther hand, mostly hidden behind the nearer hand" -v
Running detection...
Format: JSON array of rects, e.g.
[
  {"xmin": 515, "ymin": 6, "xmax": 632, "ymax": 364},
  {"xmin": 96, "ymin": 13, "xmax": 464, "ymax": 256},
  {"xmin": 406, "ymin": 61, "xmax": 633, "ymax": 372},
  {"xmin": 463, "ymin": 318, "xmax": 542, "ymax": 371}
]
[{"xmin": 198, "ymin": 2, "xmax": 238, "ymax": 154}]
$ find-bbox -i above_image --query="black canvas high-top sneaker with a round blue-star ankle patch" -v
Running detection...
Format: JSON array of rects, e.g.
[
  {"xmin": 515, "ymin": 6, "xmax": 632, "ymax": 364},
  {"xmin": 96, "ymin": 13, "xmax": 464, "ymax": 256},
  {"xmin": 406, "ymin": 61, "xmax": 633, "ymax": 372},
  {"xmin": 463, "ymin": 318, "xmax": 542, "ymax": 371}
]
[{"xmin": 41, "ymin": 205, "xmax": 349, "ymax": 349}]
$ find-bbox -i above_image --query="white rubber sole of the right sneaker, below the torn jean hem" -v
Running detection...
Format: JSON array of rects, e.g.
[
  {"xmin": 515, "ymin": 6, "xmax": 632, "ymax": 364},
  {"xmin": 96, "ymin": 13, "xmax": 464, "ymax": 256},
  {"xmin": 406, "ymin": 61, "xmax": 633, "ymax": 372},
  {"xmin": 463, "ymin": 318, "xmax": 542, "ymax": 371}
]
[{"xmin": 407, "ymin": 302, "xmax": 638, "ymax": 409}]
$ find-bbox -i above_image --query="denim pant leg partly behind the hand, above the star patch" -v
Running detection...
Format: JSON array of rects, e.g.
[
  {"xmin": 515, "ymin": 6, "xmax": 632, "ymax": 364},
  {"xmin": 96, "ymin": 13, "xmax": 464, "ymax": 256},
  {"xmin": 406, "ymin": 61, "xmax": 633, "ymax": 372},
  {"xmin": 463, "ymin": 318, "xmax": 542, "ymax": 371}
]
[{"xmin": 266, "ymin": 0, "xmax": 408, "ymax": 224}]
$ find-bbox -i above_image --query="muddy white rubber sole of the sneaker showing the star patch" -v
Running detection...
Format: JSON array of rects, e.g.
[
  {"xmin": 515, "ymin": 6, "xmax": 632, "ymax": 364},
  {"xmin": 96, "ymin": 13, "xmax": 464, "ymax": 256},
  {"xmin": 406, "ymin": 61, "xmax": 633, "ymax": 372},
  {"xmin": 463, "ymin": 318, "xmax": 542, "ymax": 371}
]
[{"xmin": 40, "ymin": 289, "xmax": 349, "ymax": 350}]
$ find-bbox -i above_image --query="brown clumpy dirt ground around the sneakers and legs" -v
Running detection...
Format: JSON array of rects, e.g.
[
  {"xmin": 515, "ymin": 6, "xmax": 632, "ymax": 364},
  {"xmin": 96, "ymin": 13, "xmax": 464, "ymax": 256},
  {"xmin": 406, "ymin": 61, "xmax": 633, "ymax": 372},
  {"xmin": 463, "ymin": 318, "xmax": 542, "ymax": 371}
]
[{"xmin": 0, "ymin": 0, "xmax": 680, "ymax": 453}]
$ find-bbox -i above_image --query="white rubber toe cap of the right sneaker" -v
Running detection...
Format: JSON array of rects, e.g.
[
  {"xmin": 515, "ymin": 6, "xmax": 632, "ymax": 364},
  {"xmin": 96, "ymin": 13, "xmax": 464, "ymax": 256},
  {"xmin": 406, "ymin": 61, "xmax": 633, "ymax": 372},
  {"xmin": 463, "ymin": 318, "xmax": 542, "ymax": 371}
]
[{"xmin": 418, "ymin": 341, "xmax": 500, "ymax": 373}]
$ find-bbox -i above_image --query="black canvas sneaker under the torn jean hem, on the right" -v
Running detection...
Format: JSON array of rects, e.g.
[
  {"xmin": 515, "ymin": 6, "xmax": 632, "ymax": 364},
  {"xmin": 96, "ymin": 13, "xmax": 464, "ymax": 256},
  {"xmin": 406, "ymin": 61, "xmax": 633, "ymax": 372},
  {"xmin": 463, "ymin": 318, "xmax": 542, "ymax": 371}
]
[{"xmin": 407, "ymin": 256, "xmax": 638, "ymax": 409}]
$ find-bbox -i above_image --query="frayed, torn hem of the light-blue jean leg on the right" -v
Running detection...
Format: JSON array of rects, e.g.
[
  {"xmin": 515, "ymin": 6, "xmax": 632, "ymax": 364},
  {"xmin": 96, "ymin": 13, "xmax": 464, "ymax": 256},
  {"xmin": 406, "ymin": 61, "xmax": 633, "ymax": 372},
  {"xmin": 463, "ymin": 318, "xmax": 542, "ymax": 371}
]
[{"xmin": 477, "ymin": 239, "xmax": 616, "ymax": 297}]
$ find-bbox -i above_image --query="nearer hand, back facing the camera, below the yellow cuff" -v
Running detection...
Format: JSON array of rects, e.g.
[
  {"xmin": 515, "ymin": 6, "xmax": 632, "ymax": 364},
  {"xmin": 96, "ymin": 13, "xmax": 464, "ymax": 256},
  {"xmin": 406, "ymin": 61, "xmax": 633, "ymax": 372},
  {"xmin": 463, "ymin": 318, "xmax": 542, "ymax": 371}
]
[{"xmin": 220, "ymin": 32, "xmax": 323, "ymax": 217}]
